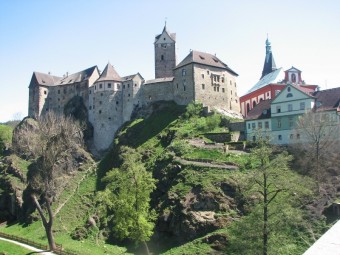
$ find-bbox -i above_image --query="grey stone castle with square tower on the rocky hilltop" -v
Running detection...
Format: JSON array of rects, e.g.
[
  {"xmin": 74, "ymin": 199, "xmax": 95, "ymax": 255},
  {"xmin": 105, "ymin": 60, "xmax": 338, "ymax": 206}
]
[{"xmin": 28, "ymin": 25, "xmax": 240, "ymax": 150}]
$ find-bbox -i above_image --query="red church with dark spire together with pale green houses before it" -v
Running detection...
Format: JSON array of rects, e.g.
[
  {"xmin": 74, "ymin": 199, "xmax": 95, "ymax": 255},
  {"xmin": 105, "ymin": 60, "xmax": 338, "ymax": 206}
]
[{"xmin": 240, "ymin": 36, "xmax": 340, "ymax": 145}]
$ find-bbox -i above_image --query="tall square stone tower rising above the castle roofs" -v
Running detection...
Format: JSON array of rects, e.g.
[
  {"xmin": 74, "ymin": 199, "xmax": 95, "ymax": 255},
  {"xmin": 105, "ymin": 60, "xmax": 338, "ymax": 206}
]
[{"xmin": 154, "ymin": 24, "xmax": 176, "ymax": 79}]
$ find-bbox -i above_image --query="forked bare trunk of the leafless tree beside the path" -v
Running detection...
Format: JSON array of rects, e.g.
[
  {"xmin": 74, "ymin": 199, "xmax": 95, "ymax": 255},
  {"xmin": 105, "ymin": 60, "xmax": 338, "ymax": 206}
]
[{"xmin": 32, "ymin": 195, "xmax": 57, "ymax": 251}]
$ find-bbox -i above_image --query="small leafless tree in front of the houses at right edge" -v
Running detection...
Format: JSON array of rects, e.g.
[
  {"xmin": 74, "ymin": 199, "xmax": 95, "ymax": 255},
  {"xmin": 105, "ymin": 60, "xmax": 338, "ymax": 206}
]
[{"xmin": 296, "ymin": 111, "xmax": 340, "ymax": 180}]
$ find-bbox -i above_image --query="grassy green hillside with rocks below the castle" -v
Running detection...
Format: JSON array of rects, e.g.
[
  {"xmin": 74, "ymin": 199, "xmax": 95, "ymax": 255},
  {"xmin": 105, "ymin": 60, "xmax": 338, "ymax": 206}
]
[{"xmin": 0, "ymin": 103, "xmax": 326, "ymax": 255}]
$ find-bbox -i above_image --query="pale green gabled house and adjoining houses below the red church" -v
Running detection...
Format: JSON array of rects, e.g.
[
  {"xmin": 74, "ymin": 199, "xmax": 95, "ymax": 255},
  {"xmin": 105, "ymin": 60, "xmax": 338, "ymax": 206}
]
[{"xmin": 245, "ymin": 84, "xmax": 340, "ymax": 145}]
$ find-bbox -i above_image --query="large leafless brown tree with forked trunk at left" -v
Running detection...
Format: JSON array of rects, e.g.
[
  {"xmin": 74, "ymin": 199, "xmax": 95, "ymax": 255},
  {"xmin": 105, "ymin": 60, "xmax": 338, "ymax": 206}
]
[{"xmin": 14, "ymin": 113, "xmax": 83, "ymax": 250}]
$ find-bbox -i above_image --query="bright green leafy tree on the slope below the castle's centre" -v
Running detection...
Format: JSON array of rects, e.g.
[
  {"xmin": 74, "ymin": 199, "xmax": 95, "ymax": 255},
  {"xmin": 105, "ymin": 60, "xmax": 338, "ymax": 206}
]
[{"xmin": 98, "ymin": 147, "xmax": 156, "ymax": 254}]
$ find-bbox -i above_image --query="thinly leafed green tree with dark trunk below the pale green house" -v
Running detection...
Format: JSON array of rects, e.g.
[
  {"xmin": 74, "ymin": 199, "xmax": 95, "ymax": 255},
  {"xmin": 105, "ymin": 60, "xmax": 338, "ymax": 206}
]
[{"xmin": 230, "ymin": 138, "xmax": 312, "ymax": 255}]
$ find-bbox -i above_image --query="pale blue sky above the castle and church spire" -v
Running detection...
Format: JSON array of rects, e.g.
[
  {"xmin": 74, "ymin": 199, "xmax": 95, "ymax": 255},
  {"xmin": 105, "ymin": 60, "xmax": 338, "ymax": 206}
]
[{"xmin": 0, "ymin": 0, "xmax": 340, "ymax": 122}]
